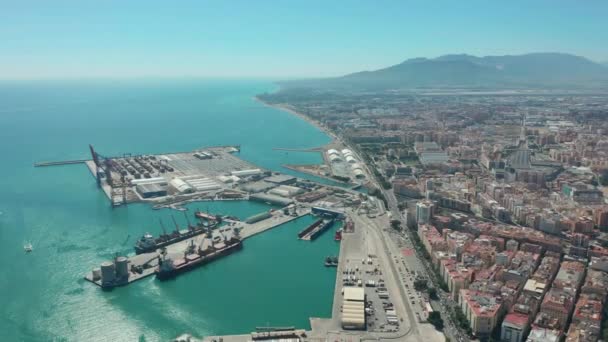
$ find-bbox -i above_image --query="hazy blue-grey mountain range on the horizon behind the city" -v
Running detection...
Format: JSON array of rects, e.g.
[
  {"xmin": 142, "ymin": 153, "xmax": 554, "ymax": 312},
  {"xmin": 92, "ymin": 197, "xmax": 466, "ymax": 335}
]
[{"xmin": 279, "ymin": 53, "xmax": 608, "ymax": 90}]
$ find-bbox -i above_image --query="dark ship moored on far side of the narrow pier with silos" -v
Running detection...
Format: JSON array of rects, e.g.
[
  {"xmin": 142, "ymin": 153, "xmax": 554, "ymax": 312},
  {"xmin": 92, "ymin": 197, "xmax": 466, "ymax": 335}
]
[{"xmin": 135, "ymin": 219, "xmax": 218, "ymax": 254}]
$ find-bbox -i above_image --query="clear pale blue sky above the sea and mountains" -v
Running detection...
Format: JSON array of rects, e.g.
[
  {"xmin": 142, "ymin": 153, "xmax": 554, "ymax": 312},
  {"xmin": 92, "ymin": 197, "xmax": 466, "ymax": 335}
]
[{"xmin": 0, "ymin": 0, "xmax": 608, "ymax": 79}]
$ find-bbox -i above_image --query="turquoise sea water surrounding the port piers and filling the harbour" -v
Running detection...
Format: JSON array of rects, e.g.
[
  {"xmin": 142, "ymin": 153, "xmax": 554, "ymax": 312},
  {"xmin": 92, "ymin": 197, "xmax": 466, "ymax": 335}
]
[{"xmin": 0, "ymin": 80, "xmax": 338, "ymax": 341}]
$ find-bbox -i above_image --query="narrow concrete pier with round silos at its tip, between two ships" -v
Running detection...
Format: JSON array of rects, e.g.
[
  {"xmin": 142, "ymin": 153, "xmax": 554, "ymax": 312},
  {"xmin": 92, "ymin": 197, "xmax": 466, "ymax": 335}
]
[{"xmin": 84, "ymin": 207, "xmax": 310, "ymax": 289}]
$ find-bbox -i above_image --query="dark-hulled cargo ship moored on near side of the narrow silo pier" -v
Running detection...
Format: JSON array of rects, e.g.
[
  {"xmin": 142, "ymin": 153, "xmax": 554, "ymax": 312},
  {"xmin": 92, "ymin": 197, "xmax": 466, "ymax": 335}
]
[{"xmin": 156, "ymin": 237, "xmax": 243, "ymax": 280}]
